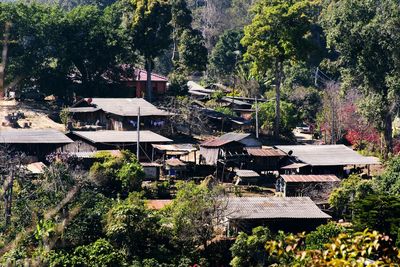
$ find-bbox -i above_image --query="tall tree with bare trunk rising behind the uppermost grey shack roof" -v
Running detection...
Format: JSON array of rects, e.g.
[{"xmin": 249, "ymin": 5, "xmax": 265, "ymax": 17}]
[{"xmin": 125, "ymin": 0, "xmax": 172, "ymax": 101}]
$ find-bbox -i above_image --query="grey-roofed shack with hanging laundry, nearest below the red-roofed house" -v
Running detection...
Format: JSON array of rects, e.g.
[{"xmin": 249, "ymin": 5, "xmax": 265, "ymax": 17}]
[{"xmin": 68, "ymin": 98, "xmax": 170, "ymax": 131}]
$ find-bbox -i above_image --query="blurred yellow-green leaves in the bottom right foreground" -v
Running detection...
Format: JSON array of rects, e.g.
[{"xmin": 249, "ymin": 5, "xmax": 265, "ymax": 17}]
[{"xmin": 265, "ymin": 230, "xmax": 400, "ymax": 267}]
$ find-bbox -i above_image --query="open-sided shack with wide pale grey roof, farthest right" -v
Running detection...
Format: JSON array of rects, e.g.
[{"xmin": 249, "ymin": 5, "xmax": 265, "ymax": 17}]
[{"xmin": 277, "ymin": 145, "xmax": 380, "ymax": 177}]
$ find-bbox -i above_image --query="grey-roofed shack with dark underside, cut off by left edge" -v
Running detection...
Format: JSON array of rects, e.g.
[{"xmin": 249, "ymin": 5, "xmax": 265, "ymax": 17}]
[{"xmin": 0, "ymin": 129, "xmax": 73, "ymax": 162}]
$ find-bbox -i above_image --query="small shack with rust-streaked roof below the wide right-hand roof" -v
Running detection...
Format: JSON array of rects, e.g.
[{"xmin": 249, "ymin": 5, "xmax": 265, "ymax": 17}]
[{"xmin": 276, "ymin": 174, "xmax": 340, "ymax": 203}]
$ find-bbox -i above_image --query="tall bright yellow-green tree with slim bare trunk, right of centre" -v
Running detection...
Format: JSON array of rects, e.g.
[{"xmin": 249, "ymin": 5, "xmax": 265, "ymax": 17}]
[{"xmin": 241, "ymin": 0, "xmax": 317, "ymax": 138}]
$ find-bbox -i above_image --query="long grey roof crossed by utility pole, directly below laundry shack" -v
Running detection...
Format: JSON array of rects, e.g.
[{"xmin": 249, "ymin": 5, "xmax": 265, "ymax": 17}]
[{"xmin": 72, "ymin": 130, "xmax": 172, "ymax": 143}]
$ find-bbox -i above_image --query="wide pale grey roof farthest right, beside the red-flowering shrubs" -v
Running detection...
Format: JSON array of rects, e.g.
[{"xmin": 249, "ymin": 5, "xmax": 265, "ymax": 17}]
[{"xmin": 277, "ymin": 145, "xmax": 379, "ymax": 166}]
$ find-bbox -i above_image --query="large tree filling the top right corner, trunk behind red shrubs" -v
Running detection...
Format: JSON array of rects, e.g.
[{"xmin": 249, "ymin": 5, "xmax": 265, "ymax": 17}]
[{"xmin": 322, "ymin": 0, "xmax": 400, "ymax": 156}]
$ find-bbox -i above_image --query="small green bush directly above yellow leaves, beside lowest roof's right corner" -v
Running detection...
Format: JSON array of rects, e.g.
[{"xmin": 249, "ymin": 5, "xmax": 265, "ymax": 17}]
[{"xmin": 305, "ymin": 222, "xmax": 346, "ymax": 250}]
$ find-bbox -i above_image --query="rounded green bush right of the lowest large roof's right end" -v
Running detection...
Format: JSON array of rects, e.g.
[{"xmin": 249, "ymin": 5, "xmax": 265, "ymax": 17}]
[{"xmin": 329, "ymin": 175, "xmax": 375, "ymax": 220}]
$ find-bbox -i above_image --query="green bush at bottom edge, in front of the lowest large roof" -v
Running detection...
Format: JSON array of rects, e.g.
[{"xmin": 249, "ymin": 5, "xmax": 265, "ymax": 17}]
[{"xmin": 231, "ymin": 226, "xmax": 271, "ymax": 267}]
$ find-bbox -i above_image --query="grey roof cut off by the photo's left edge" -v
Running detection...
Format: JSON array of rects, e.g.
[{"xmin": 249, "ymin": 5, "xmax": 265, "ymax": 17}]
[{"xmin": 0, "ymin": 129, "xmax": 73, "ymax": 144}]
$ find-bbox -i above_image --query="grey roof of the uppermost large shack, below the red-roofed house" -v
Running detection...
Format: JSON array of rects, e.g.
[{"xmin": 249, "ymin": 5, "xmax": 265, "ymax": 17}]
[{"xmin": 91, "ymin": 98, "xmax": 169, "ymax": 117}]
